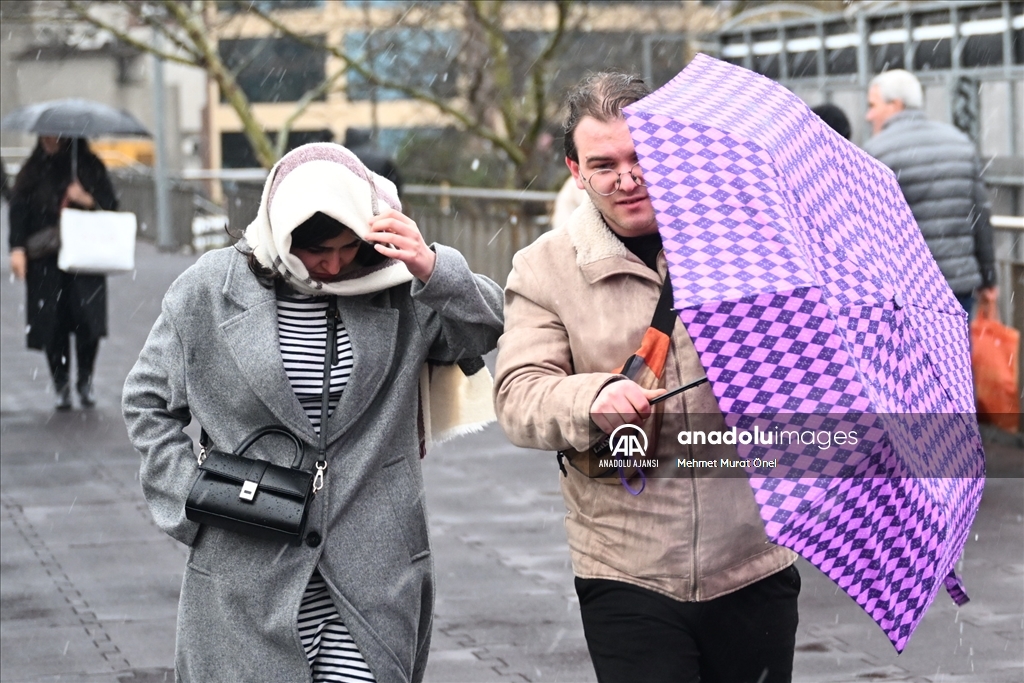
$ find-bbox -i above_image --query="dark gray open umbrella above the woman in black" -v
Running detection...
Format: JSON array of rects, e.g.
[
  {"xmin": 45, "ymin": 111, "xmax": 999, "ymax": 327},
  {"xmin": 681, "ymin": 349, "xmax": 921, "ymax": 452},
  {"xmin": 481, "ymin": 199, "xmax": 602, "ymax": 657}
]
[{"xmin": 0, "ymin": 99, "xmax": 150, "ymax": 137}]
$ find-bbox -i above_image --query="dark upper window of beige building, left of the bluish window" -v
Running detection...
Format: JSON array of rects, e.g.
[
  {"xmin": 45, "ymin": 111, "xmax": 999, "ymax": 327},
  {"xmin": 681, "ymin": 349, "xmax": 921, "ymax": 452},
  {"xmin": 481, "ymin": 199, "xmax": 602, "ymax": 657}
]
[{"xmin": 217, "ymin": 36, "xmax": 327, "ymax": 102}]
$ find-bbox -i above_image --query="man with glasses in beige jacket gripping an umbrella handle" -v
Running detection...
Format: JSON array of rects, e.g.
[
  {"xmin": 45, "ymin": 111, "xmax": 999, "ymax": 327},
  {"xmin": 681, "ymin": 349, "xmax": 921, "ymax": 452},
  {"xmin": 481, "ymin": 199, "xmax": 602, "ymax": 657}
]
[{"xmin": 496, "ymin": 74, "xmax": 800, "ymax": 683}]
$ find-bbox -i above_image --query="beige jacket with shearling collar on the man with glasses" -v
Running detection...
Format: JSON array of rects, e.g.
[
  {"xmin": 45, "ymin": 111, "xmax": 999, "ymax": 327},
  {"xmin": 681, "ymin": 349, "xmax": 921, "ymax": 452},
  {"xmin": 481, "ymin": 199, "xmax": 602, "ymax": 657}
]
[{"xmin": 495, "ymin": 200, "xmax": 796, "ymax": 601}]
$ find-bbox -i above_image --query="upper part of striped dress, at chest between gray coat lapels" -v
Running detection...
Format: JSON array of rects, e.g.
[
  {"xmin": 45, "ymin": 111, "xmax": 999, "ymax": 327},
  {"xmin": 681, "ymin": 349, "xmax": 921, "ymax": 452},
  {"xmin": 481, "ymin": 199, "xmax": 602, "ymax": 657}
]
[{"xmin": 278, "ymin": 294, "xmax": 352, "ymax": 433}]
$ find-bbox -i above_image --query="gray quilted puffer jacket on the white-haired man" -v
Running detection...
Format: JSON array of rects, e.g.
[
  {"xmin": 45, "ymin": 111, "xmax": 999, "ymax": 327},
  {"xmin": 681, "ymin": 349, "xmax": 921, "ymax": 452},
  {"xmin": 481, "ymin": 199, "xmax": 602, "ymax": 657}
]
[{"xmin": 864, "ymin": 110, "xmax": 995, "ymax": 295}]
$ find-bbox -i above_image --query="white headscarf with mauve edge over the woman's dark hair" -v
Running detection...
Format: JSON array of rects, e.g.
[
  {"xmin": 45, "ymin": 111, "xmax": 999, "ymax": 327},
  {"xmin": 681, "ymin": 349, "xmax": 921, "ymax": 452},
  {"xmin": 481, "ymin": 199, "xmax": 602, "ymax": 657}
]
[{"xmin": 245, "ymin": 142, "xmax": 413, "ymax": 296}]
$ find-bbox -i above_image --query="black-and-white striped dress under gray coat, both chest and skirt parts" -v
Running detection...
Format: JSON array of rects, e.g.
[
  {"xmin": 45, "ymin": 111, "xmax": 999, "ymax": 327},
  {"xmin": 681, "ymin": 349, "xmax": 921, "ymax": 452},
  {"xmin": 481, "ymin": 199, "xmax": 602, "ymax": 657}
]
[{"xmin": 278, "ymin": 292, "xmax": 374, "ymax": 683}]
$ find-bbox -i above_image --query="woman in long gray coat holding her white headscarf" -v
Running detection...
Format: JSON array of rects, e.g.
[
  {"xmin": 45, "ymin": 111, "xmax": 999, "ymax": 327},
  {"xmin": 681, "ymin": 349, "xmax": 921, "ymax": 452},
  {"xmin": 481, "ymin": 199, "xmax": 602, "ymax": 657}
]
[{"xmin": 124, "ymin": 143, "xmax": 502, "ymax": 683}]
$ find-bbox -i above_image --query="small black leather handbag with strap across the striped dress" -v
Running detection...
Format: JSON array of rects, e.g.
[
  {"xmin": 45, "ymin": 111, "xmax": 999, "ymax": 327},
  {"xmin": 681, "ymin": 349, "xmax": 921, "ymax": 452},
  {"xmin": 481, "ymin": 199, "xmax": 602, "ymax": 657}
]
[{"xmin": 185, "ymin": 297, "xmax": 338, "ymax": 545}]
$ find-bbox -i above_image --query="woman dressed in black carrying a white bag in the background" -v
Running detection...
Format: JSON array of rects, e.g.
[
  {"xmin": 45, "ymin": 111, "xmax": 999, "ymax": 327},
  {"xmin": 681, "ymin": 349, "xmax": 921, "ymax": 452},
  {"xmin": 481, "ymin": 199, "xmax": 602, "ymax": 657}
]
[{"xmin": 10, "ymin": 135, "xmax": 118, "ymax": 411}]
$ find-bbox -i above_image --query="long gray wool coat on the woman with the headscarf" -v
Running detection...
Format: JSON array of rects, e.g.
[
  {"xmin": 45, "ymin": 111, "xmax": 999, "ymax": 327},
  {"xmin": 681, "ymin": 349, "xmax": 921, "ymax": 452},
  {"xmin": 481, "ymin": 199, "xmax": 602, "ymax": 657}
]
[{"xmin": 123, "ymin": 246, "xmax": 503, "ymax": 683}]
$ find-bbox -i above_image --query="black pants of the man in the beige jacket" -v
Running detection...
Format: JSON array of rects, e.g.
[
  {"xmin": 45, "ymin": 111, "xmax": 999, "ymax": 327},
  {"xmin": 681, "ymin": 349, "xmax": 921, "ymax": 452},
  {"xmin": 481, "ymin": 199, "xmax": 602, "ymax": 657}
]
[{"xmin": 575, "ymin": 566, "xmax": 800, "ymax": 683}]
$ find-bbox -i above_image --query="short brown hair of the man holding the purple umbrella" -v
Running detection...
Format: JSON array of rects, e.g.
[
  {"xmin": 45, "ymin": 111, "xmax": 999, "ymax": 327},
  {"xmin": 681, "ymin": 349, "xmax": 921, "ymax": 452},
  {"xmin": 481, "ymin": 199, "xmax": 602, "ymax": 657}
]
[{"xmin": 562, "ymin": 72, "xmax": 650, "ymax": 163}]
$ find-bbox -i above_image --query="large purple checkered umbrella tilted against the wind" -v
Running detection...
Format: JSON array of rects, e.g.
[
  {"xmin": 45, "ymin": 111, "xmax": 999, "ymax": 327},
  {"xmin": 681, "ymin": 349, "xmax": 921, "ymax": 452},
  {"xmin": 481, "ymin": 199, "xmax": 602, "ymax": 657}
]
[{"xmin": 626, "ymin": 54, "xmax": 984, "ymax": 651}]
